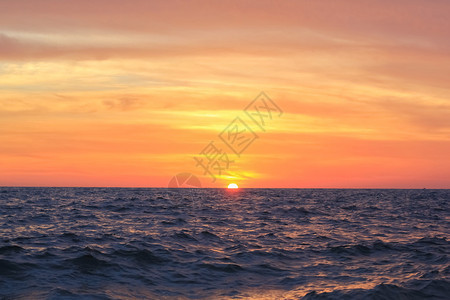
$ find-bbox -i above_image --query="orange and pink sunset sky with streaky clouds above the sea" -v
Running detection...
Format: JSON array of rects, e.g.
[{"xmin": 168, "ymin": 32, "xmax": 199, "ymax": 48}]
[{"xmin": 0, "ymin": 0, "xmax": 450, "ymax": 188}]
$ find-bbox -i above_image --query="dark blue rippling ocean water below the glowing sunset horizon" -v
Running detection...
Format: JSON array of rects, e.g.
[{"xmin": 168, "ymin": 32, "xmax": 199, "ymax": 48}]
[{"xmin": 0, "ymin": 187, "xmax": 450, "ymax": 300}]
